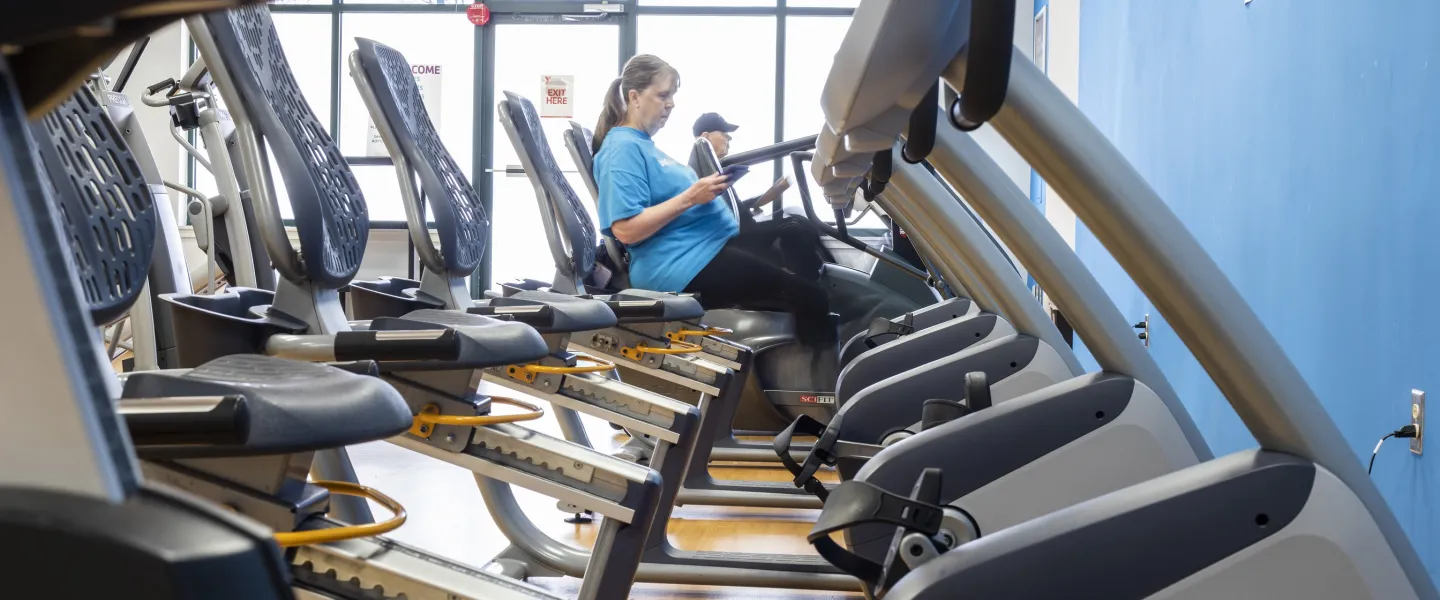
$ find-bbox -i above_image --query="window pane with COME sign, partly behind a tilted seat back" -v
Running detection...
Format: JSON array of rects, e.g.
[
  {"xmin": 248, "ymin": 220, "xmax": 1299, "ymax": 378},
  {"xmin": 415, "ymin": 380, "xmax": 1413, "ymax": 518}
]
[{"xmin": 340, "ymin": 13, "xmax": 475, "ymax": 220}]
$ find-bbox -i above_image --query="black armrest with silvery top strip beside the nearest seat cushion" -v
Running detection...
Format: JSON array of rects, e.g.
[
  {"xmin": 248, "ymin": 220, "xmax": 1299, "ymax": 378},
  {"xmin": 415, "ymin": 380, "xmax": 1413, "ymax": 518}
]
[{"xmin": 118, "ymin": 396, "xmax": 251, "ymax": 447}]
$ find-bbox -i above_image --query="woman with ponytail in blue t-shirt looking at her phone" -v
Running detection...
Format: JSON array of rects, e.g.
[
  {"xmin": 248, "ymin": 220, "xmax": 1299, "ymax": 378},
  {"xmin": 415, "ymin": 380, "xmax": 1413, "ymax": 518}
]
[{"xmin": 593, "ymin": 55, "xmax": 838, "ymax": 354}]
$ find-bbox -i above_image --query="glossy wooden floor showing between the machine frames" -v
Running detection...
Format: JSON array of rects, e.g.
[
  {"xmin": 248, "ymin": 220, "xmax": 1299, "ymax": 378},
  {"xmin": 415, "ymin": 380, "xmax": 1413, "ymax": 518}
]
[{"xmin": 350, "ymin": 379, "xmax": 861, "ymax": 600}]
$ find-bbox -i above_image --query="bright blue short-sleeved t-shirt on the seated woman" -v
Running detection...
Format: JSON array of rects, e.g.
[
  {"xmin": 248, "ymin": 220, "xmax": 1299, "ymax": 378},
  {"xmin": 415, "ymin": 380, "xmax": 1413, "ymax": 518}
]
[{"xmin": 595, "ymin": 127, "xmax": 740, "ymax": 292}]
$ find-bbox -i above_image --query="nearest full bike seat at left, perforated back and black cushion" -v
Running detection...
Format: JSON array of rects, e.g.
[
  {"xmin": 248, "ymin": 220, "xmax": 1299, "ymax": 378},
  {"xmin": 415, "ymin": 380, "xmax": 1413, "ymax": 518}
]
[{"xmin": 30, "ymin": 79, "xmax": 410, "ymax": 466}]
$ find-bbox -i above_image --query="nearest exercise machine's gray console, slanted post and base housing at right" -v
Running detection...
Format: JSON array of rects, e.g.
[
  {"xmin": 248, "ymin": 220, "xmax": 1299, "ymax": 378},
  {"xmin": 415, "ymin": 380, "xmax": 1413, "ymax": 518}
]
[{"xmin": 814, "ymin": 0, "xmax": 1440, "ymax": 600}]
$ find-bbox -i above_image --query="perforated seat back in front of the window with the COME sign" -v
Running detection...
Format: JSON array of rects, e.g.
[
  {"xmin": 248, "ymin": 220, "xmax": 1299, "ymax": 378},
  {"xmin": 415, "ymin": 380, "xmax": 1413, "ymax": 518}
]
[{"xmin": 356, "ymin": 37, "xmax": 490, "ymax": 276}]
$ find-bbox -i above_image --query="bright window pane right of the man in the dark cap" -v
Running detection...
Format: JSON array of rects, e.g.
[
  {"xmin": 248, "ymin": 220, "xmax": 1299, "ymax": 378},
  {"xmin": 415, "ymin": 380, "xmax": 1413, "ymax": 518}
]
[{"xmin": 785, "ymin": 16, "xmax": 884, "ymax": 229}]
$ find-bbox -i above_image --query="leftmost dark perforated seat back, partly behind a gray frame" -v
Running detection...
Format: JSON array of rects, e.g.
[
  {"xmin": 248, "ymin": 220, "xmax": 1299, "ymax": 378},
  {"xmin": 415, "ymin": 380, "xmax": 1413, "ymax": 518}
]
[{"xmin": 30, "ymin": 88, "xmax": 156, "ymax": 325}]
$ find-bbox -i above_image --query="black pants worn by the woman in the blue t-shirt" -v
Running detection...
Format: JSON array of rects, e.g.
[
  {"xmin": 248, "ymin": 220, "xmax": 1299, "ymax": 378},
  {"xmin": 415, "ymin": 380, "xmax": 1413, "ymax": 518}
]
[{"xmin": 685, "ymin": 219, "xmax": 837, "ymax": 345}]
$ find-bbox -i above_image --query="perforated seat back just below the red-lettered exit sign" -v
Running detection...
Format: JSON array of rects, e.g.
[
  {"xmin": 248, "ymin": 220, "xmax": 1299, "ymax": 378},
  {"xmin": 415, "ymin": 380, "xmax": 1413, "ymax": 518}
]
[{"xmin": 500, "ymin": 92, "xmax": 599, "ymax": 290}]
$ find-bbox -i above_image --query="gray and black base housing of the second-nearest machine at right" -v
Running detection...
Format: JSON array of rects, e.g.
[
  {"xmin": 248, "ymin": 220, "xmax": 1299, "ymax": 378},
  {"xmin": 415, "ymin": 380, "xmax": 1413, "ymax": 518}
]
[{"xmin": 845, "ymin": 373, "xmax": 1200, "ymax": 561}]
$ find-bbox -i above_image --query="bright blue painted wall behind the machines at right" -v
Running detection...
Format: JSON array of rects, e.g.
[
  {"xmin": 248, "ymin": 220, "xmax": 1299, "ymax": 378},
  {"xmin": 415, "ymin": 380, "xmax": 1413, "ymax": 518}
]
[{"xmin": 1076, "ymin": 0, "xmax": 1440, "ymax": 580}]
